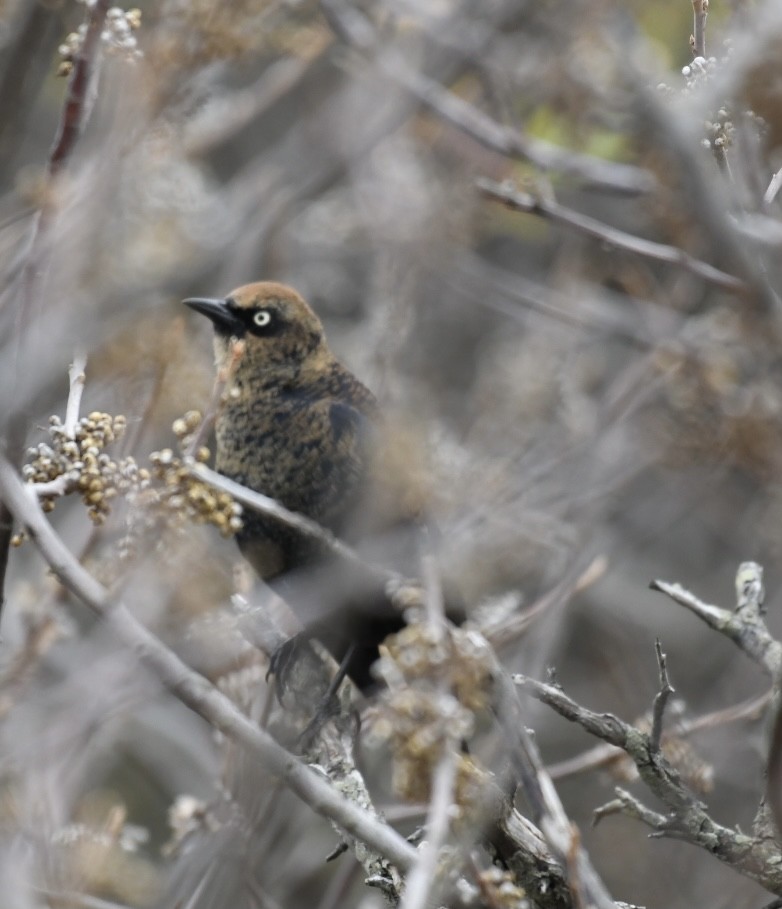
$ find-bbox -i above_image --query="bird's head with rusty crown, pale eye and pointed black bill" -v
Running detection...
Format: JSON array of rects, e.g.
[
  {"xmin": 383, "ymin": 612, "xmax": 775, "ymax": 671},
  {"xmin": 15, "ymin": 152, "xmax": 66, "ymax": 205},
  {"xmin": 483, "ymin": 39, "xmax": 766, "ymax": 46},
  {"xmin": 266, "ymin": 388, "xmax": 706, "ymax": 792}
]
[{"xmin": 184, "ymin": 281, "xmax": 327, "ymax": 368}]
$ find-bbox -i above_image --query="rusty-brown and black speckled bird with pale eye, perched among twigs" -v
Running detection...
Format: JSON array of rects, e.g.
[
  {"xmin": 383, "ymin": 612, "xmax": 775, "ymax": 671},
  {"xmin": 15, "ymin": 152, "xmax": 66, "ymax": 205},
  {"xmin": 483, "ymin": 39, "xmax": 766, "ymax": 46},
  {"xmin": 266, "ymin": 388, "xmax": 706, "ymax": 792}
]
[{"xmin": 183, "ymin": 281, "xmax": 422, "ymax": 691}]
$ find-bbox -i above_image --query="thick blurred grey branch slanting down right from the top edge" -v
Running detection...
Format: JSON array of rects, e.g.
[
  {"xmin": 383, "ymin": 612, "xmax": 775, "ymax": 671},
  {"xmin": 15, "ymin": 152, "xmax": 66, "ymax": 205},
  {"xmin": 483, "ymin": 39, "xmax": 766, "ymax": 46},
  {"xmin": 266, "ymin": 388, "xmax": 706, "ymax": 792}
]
[{"xmin": 320, "ymin": 0, "xmax": 656, "ymax": 194}]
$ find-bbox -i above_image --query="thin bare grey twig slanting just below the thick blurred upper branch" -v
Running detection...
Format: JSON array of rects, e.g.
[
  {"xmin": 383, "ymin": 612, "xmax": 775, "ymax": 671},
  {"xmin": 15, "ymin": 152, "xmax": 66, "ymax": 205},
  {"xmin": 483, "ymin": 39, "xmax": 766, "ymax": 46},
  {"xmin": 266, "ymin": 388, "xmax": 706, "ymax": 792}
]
[{"xmin": 477, "ymin": 178, "xmax": 747, "ymax": 292}]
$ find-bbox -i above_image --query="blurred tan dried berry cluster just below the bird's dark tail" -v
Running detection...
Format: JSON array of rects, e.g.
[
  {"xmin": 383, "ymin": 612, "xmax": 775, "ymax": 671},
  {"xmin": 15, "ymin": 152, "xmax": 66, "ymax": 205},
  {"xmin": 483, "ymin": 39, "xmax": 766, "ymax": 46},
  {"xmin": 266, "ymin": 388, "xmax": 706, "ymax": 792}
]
[{"xmin": 372, "ymin": 621, "xmax": 491, "ymax": 809}]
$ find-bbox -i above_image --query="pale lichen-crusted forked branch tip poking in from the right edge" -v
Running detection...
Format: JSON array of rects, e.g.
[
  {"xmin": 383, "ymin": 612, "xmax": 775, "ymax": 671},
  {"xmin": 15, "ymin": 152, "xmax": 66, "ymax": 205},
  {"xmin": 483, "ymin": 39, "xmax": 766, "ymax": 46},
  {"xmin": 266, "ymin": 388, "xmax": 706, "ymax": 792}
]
[{"xmin": 649, "ymin": 562, "xmax": 782, "ymax": 680}]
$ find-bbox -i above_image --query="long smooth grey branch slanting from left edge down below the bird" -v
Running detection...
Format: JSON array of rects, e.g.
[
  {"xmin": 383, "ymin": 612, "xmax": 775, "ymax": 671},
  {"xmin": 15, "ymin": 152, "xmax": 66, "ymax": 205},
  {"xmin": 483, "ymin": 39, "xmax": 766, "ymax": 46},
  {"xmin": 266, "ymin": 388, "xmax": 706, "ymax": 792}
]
[{"xmin": 0, "ymin": 458, "xmax": 416, "ymax": 871}]
